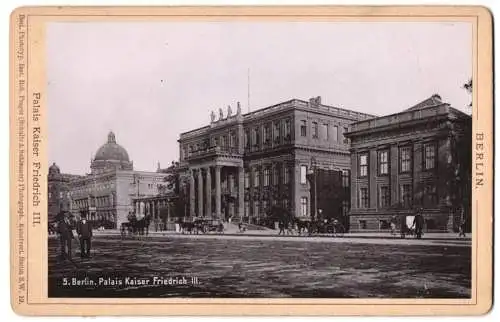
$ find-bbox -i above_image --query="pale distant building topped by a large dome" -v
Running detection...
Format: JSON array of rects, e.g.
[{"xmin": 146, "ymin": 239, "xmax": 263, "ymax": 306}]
[{"xmin": 49, "ymin": 132, "xmax": 165, "ymax": 229}]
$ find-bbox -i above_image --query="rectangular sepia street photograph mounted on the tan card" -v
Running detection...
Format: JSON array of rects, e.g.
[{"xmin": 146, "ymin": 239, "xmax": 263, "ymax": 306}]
[{"xmin": 46, "ymin": 21, "xmax": 475, "ymax": 299}]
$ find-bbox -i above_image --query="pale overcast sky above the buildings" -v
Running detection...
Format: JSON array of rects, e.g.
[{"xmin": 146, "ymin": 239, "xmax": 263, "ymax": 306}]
[{"xmin": 47, "ymin": 22, "xmax": 472, "ymax": 174}]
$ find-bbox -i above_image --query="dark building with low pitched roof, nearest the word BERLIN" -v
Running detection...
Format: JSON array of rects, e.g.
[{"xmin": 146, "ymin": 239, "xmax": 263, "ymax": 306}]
[{"xmin": 346, "ymin": 95, "xmax": 472, "ymax": 231}]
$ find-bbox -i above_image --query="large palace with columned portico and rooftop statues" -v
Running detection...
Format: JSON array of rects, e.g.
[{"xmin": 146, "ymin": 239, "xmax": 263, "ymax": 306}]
[{"xmin": 179, "ymin": 97, "xmax": 373, "ymax": 223}]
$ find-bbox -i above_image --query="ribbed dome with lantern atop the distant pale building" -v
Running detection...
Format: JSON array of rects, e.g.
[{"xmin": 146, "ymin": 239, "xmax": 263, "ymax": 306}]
[{"xmin": 90, "ymin": 131, "xmax": 133, "ymax": 173}]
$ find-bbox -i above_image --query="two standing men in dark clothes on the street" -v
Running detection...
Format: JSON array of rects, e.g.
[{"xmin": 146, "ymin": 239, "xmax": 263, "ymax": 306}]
[{"xmin": 57, "ymin": 213, "xmax": 92, "ymax": 260}]
